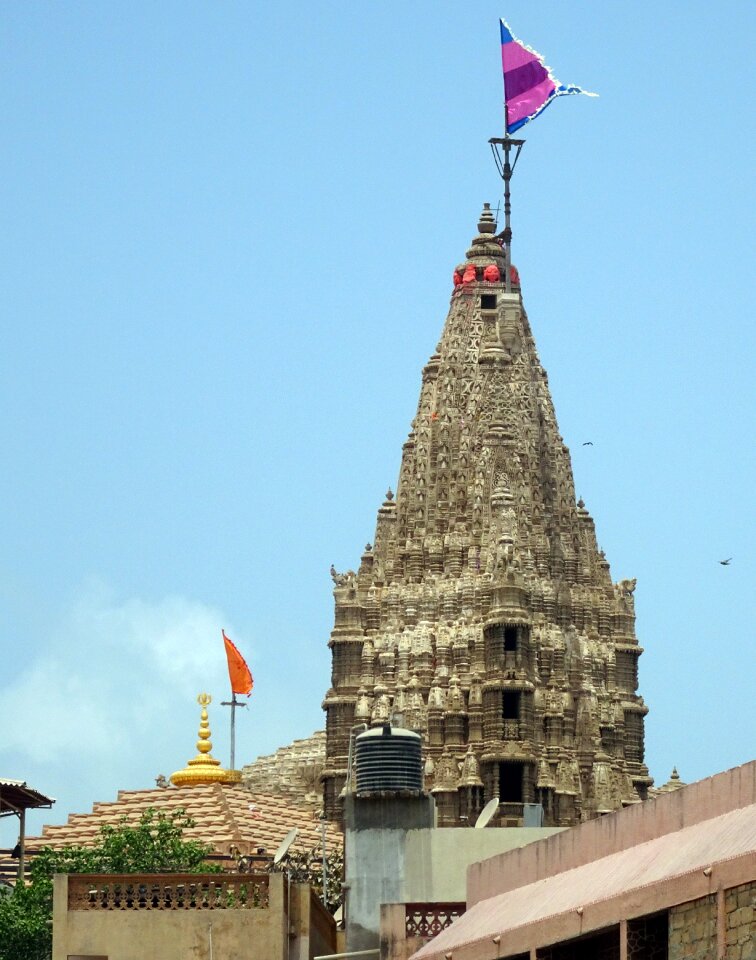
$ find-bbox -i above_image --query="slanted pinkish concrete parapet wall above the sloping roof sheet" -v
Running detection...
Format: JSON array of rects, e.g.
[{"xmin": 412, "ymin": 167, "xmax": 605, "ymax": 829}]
[{"xmin": 467, "ymin": 760, "xmax": 756, "ymax": 907}]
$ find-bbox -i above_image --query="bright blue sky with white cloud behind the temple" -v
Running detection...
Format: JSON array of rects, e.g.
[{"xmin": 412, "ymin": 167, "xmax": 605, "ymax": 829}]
[{"xmin": 0, "ymin": 0, "xmax": 756, "ymax": 842}]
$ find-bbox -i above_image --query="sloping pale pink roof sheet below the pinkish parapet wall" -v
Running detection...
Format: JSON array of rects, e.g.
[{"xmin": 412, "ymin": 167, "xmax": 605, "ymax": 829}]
[{"xmin": 412, "ymin": 804, "xmax": 756, "ymax": 960}]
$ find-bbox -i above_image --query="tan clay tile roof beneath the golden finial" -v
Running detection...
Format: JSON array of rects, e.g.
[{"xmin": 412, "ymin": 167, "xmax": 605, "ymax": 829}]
[{"xmin": 27, "ymin": 783, "xmax": 342, "ymax": 856}]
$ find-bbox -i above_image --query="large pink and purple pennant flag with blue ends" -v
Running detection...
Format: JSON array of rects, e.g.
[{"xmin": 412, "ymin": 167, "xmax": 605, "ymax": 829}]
[{"xmin": 499, "ymin": 20, "xmax": 598, "ymax": 133}]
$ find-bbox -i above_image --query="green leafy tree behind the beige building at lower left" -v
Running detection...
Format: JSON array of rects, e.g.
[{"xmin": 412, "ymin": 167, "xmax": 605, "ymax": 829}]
[{"xmin": 0, "ymin": 809, "xmax": 220, "ymax": 960}]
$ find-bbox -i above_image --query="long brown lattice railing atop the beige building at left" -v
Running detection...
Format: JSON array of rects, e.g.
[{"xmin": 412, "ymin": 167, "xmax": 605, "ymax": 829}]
[{"xmin": 68, "ymin": 873, "xmax": 269, "ymax": 910}]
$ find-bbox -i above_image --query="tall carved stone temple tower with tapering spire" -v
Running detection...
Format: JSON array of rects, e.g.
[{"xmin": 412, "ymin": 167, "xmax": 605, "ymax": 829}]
[{"xmin": 323, "ymin": 204, "xmax": 652, "ymax": 826}]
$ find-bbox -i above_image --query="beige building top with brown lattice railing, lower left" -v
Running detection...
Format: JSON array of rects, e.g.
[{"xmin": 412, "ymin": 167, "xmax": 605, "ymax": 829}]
[{"xmin": 52, "ymin": 873, "xmax": 337, "ymax": 960}]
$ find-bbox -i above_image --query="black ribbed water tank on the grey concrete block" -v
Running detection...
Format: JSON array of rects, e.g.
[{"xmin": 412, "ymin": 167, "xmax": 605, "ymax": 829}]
[{"xmin": 356, "ymin": 724, "xmax": 423, "ymax": 797}]
